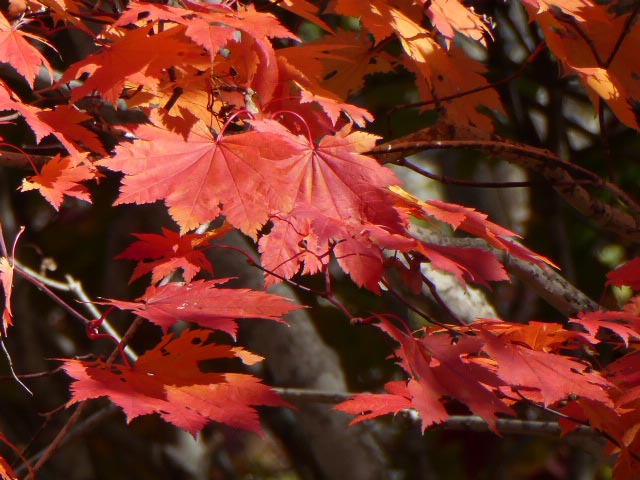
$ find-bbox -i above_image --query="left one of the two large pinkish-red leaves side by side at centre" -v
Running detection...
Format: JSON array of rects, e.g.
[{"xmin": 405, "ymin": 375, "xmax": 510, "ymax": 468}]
[{"xmin": 97, "ymin": 123, "xmax": 292, "ymax": 236}]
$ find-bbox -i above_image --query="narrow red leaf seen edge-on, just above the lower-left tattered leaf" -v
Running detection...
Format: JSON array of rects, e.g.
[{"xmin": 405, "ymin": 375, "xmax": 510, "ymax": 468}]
[{"xmin": 109, "ymin": 279, "xmax": 301, "ymax": 339}]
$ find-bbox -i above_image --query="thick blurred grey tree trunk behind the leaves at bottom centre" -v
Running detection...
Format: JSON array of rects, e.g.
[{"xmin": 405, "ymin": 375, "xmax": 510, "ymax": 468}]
[{"xmin": 214, "ymin": 231, "xmax": 390, "ymax": 480}]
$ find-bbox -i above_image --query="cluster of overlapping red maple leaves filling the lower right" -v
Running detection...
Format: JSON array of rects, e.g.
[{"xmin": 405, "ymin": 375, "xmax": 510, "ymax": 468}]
[{"xmin": 335, "ymin": 258, "xmax": 640, "ymax": 478}]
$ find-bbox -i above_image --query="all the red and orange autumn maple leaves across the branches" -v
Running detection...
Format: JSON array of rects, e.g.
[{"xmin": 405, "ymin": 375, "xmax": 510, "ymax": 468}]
[{"xmin": 0, "ymin": 0, "xmax": 640, "ymax": 477}]
